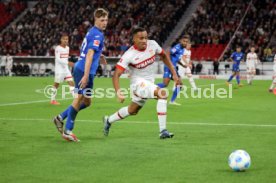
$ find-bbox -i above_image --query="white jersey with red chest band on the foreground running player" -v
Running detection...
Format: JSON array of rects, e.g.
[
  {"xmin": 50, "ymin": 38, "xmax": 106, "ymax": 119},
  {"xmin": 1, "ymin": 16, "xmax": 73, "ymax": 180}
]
[{"xmin": 116, "ymin": 40, "xmax": 163, "ymax": 84}]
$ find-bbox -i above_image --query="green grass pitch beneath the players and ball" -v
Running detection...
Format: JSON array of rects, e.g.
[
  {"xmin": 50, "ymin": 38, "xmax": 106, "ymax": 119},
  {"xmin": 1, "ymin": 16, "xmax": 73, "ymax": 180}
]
[{"xmin": 0, "ymin": 77, "xmax": 276, "ymax": 183}]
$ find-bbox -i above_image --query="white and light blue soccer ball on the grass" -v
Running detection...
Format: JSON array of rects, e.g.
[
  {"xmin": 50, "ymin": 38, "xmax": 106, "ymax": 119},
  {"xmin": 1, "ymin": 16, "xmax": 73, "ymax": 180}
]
[{"xmin": 228, "ymin": 150, "xmax": 251, "ymax": 172}]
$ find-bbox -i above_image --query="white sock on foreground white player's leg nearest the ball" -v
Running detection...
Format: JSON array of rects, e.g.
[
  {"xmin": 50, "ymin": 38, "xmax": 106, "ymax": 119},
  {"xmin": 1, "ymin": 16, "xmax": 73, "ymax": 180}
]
[{"xmin": 156, "ymin": 99, "xmax": 167, "ymax": 132}]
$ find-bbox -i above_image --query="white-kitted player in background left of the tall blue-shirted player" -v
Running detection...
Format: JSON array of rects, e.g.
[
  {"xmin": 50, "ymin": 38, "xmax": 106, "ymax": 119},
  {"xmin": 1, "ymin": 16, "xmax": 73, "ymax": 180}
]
[{"xmin": 51, "ymin": 34, "xmax": 75, "ymax": 105}]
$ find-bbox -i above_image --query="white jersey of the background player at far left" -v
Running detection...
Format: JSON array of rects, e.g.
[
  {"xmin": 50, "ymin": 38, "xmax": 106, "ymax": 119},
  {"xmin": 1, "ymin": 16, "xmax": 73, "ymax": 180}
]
[{"xmin": 55, "ymin": 45, "xmax": 69, "ymax": 73}]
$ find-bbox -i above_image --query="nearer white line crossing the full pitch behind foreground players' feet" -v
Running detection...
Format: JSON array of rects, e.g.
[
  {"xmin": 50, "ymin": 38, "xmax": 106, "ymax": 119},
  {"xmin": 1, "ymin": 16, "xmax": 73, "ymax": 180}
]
[{"xmin": 0, "ymin": 118, "xmax": 276, "ymax": 128}]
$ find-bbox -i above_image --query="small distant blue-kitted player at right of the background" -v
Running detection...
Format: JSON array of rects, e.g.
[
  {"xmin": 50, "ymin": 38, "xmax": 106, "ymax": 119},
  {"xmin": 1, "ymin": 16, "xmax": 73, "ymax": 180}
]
[{"xmin": 226, "ymin": 46, "xmax": 244, "ymax": 86}]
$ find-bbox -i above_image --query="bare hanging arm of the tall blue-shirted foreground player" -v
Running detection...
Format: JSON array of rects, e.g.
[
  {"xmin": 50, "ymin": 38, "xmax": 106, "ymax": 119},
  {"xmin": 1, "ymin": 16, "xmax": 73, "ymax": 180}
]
[{"xmin": 79, "ymin": 49, "xmax": 94, "ymax": 88}]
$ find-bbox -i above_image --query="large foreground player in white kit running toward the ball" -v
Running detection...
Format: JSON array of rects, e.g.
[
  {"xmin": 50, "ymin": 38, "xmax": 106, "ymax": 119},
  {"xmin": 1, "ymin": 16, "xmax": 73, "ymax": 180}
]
[{"xmin": 103, "ymin": 27, "xmax": 180, "ymax": 139}]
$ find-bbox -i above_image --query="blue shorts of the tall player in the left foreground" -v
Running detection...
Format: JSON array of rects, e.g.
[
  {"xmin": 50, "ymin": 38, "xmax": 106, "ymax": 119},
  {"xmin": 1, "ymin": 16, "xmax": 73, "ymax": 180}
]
[{"xmin": 73, "ymin": 68, "xmax": 94, "ymax": 96}]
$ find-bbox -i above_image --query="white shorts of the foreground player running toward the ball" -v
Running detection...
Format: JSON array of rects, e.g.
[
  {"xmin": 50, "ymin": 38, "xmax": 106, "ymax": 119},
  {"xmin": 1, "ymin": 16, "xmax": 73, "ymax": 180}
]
[{"xmin": 130, "ymin": 79, "xmax": 158, "ymax": 106}]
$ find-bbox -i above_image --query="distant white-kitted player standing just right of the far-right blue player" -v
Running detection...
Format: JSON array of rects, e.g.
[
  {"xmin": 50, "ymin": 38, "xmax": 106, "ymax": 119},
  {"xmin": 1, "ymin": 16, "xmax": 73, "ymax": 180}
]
[{"xmin": 246, "ymin": 46, "xmax": 258, "ymax": 85}]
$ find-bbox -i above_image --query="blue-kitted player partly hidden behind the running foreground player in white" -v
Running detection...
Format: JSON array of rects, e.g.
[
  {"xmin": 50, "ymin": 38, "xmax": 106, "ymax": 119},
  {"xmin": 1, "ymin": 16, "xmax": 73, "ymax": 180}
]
[{"xmin": 157, "ymin": 35, "xmax": 189, "ymax": 105}]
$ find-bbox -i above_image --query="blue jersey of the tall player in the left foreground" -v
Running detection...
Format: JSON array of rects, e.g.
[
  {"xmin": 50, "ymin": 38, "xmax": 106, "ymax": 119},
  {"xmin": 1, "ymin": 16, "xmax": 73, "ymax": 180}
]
[{"xmin": 75, "ymin": 27, "xmax": 104, "ymax": 75}]
